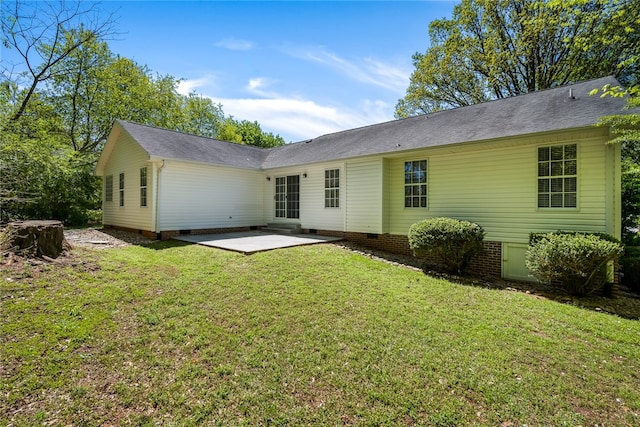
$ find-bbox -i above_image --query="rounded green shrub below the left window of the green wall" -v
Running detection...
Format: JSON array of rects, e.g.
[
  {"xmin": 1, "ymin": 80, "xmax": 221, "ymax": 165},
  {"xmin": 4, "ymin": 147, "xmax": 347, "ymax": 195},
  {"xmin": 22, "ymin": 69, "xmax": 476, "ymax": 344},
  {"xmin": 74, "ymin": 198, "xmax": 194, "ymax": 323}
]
[{"xmin": 408, "ymin": 218, "xmax": 484, "ymax": 274}]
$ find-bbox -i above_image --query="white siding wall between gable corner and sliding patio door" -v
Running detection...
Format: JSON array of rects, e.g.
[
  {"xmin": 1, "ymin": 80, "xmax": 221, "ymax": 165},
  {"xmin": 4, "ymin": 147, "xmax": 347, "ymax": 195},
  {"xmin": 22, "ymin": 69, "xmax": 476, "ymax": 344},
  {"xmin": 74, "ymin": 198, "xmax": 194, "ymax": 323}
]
[{"xmin": 158, "ymin": 161, "xmax": 266, "ymax": 231}]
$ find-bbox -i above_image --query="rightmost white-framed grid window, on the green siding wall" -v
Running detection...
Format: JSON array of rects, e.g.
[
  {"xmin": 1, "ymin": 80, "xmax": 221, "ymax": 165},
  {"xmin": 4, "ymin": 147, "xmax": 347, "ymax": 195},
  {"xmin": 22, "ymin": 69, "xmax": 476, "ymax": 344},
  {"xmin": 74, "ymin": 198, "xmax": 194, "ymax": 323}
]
[{"xmin": 538, "ymin": 144, "xmax": 578, "ymax": 208}]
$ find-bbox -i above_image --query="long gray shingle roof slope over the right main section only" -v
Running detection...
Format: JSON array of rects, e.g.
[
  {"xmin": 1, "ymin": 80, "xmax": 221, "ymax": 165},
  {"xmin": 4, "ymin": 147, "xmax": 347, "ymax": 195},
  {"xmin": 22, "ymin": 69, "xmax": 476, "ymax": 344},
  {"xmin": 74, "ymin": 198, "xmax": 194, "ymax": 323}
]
[{"xmin": 262, "ymin": 77, "xmax": 625, "ymax": 169}]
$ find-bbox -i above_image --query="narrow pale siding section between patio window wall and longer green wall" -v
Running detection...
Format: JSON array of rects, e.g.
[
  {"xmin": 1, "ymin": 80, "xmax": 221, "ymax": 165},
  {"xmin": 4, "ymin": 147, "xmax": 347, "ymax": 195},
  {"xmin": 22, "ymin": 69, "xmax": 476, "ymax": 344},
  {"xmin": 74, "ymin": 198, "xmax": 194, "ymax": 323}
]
[{"xmin": 345, "ymin": 159, "xmax": 382, "ymax": 234}]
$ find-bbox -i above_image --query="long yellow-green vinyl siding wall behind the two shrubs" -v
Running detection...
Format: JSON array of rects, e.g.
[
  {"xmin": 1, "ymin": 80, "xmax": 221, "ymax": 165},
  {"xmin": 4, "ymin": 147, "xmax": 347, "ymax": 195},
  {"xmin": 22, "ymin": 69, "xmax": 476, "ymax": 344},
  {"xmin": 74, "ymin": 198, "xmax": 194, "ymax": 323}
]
[{"xmin": 389, "ymin": 129, "xmax": 615, "ymax": 243}]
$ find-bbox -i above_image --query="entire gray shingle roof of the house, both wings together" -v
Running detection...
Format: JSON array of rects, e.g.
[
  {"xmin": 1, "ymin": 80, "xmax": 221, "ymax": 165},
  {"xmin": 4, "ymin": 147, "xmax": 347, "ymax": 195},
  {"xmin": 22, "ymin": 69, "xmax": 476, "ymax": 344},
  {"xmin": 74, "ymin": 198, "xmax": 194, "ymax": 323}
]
[{"xmin": 118, "ymin": 77, "xmax": 625, "ymax": 169}]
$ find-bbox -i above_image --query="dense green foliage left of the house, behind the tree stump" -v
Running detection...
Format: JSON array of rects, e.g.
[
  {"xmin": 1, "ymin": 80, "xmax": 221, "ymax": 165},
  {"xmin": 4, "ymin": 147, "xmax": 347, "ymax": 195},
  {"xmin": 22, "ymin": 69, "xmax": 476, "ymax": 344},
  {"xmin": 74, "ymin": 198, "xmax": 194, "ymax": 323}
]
[{"xmin": 0, "ymin": 89, "xmax": 100, "ymax": 224}]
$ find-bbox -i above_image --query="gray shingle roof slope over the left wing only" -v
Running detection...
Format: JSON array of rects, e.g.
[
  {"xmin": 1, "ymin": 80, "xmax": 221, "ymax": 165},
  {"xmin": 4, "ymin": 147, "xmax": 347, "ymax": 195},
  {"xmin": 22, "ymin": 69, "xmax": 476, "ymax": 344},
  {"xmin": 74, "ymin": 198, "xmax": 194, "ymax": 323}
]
[{"xmin": 117, "ymin": 120, "xmax": 268, "ymax": 169}]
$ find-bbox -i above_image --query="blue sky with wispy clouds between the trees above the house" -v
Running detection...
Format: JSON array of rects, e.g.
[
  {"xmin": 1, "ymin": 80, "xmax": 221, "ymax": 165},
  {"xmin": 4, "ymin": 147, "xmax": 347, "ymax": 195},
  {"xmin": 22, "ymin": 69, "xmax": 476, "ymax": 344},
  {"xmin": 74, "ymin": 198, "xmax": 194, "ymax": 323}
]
[{"xmin": 103, "ymin": 1, "xmax": 455, "ymax": 142}]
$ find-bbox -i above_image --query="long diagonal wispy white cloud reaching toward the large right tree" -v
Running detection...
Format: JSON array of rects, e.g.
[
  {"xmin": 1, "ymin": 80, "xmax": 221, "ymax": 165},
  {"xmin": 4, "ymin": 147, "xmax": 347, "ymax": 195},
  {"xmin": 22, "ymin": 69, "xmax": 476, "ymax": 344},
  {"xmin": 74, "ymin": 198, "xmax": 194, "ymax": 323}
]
[{"xmin": 284, "ymin": 47, "xmax": 411, "ymax": 94}]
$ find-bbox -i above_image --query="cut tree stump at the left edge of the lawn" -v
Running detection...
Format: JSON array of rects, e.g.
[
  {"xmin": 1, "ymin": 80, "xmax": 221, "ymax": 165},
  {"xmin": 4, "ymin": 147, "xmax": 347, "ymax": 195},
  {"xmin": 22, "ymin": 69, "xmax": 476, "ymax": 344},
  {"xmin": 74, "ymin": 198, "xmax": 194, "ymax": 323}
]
[{"xmin": 2, "ymin": 221, "xmax": 71, "ymax": 258}]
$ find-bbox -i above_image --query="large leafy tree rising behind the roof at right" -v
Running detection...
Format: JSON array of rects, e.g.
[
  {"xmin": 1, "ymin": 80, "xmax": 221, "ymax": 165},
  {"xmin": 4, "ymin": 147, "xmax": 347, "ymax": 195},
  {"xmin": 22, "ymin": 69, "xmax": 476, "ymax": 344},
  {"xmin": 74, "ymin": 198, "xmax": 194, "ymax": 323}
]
[{"xmin": 396, "ymin": 0, "xmax": 640, "ymax": 117}]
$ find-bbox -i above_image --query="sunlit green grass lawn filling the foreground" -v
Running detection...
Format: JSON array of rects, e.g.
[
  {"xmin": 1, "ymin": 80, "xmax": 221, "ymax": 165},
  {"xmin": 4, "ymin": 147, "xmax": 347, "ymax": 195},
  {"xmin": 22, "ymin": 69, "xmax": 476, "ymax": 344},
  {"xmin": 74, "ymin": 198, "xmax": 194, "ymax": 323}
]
[{"xmin": 0, "ymin": 242, "xmax": 640, "ymax": 426}]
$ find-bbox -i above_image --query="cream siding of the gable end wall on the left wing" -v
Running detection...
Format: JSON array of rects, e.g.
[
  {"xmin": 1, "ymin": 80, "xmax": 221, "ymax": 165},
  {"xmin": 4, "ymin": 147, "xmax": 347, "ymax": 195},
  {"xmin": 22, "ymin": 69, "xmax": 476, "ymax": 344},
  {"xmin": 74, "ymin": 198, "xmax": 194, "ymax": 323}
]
[{"xmin": 102, "ymin": 132, "xmax": 154, "ymax": 230}]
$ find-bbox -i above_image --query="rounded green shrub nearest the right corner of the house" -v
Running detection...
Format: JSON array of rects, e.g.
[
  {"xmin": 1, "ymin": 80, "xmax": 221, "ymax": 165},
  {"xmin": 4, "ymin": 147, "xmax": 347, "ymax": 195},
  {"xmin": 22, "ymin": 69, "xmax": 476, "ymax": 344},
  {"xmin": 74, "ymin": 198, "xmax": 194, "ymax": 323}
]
[{"xmin": 526, "ymin": 232, "xmax": 623, "ymax": 296}]
